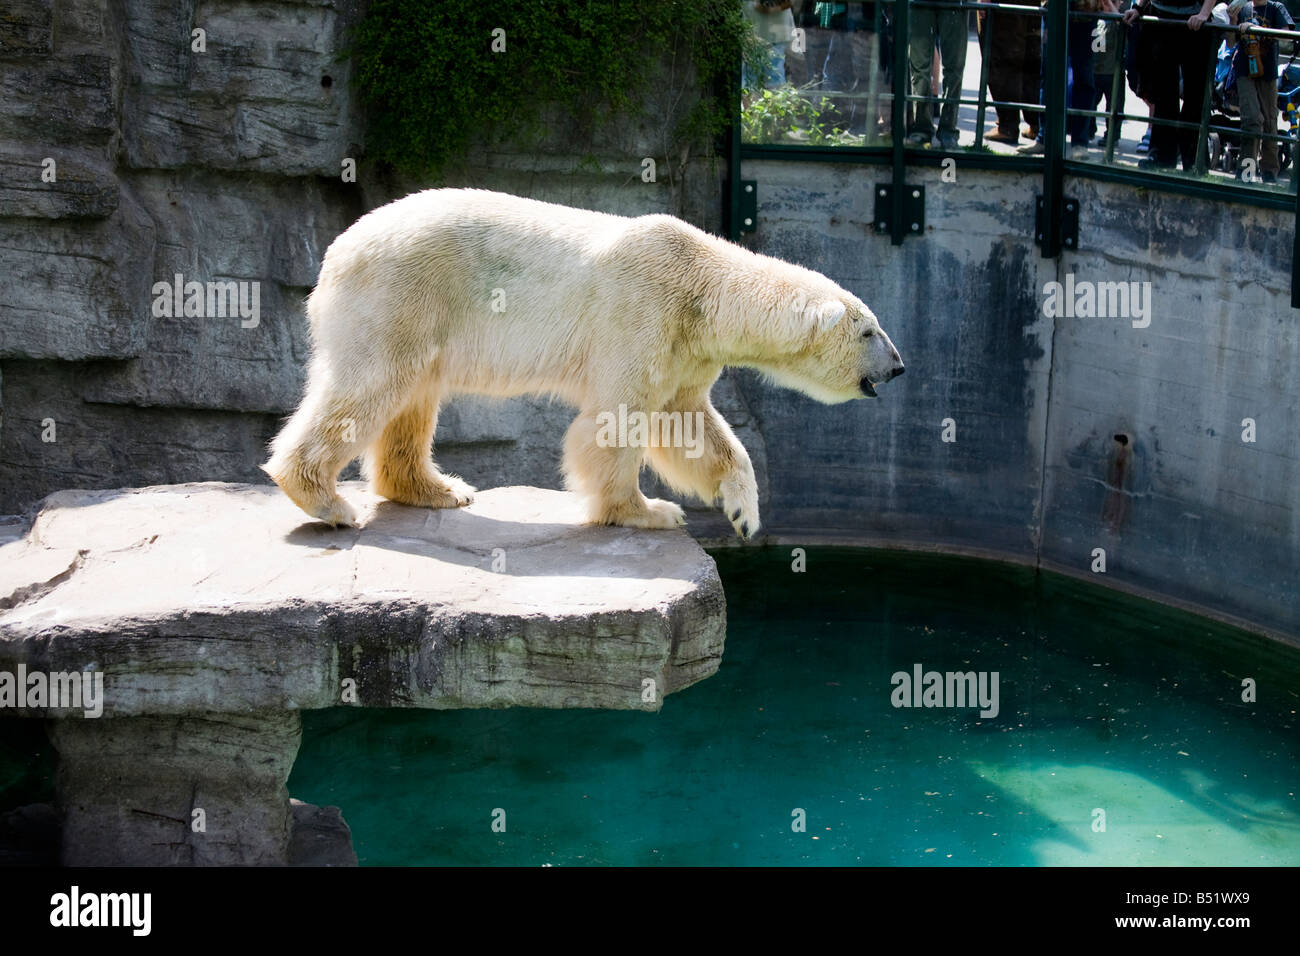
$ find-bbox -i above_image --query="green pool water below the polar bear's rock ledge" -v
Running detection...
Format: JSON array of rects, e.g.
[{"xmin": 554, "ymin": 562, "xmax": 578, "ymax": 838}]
[{"xmin": 289, "ymin": 549, "xmax": 1300, "ymax": 866}]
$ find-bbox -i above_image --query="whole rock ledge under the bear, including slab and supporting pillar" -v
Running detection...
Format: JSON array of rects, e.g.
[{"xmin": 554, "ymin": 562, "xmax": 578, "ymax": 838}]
[{"xmin": 0, "ymin": 483, "xmax": 725, "ymax": 865}]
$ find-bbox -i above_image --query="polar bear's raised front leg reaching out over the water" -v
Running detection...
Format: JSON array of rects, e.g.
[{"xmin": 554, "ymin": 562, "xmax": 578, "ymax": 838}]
[{"xmin": 647, "ymin": 395, "xmax": 759, "ymax": 540}]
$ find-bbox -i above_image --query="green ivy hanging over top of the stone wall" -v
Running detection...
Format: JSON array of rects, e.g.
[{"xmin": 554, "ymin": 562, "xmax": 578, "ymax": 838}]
[{"xmin": 352, "ymin": 0, "xmax": 753, "ymax": 176}]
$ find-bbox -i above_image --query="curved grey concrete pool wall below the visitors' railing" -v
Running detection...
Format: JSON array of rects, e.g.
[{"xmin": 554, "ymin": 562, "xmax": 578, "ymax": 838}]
[{"xmin": 735, "ymin": 161, "xmax": 1300, "ymax": 644}]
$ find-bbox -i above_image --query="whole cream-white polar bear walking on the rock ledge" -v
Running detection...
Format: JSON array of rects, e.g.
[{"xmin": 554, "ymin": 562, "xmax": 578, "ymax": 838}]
[{"xmin": 263, "ymin": 189, "xmax": 904, "ymax": 538}]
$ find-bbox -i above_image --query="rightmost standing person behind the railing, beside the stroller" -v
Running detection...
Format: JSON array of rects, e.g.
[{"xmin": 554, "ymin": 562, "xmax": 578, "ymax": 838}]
[{"xmin": 1227, "ymin": 0, "xmax": 1295, "ymax": 182}]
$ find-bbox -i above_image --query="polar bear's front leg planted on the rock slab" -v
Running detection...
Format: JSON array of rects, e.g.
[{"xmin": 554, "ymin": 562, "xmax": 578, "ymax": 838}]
[{"xmin": 564, "ymin": 412, "xmax": 686, "ymax": 528}]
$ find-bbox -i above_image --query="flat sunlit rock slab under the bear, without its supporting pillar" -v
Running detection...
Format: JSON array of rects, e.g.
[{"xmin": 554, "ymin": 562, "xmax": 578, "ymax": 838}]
[{"xmin": 0, "ymin": 483, "xmax": 725, "ymax": 722}]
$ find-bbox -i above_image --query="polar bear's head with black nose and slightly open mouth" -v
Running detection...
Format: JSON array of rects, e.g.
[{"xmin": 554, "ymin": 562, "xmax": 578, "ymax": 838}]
[{"xmin": 759, "ymin": 282, "xmax": 904, "ymax": 405}]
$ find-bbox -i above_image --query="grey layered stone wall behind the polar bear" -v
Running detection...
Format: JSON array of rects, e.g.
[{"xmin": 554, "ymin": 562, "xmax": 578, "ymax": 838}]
[{"xmin": 0, "ymin": 0, "xmax": 723, "ymax": 514}]
